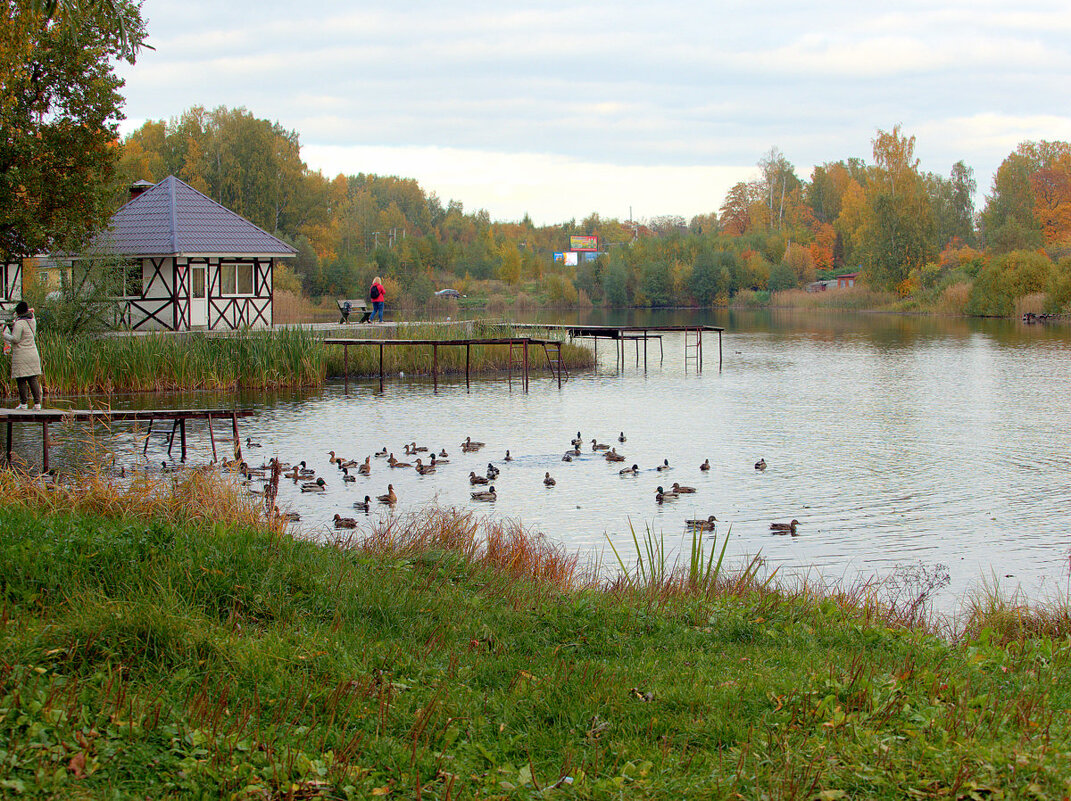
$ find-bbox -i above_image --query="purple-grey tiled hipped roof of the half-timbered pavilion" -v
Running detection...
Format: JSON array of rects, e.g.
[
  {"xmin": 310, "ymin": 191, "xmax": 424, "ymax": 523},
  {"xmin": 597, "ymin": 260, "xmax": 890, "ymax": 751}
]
[{"xmin": 91, "ymin": 176, "xmax": 297, "ymax": 258}]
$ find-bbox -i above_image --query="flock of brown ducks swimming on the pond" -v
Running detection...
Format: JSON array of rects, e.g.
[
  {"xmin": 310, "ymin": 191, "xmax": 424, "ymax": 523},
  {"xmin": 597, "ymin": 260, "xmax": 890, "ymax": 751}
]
[{"xmin": 240, "ymin": 432, "xmax": 799, "ymax": 536}]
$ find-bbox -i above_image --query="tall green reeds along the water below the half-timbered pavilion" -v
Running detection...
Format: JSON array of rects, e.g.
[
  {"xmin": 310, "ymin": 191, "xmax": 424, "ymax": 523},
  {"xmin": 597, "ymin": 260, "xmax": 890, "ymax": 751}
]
[{"xmin": 3, "ymin": 323, "xmax": 593, "ymax": 396}]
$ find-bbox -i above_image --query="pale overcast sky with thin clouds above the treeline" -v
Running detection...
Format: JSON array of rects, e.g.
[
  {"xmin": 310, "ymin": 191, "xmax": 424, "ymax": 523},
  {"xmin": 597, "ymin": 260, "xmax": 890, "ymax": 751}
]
[{"xmin": 121, "ymin": 0, "xmax": 1071, "ymax": 224}]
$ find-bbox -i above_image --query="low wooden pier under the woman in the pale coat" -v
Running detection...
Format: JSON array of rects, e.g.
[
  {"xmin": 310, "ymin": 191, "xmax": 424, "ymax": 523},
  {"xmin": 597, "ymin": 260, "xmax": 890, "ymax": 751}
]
[{"xmin": 0, "ymin": 409, "xmax": 254, "ymax": 472}]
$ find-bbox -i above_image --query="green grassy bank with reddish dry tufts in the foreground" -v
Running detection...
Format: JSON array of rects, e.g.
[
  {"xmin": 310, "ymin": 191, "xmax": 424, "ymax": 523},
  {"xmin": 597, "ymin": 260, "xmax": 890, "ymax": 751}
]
[{"xmin": 0, "ymin": 473, "xmax": 1071, "ymax": 799}]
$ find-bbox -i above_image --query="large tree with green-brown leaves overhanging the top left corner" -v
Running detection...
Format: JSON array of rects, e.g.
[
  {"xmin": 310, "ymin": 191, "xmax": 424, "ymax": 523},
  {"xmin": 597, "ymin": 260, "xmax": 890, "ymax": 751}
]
[{"xmin": 0, "ymin": 3, "xmax": 145, "ymax": 260}]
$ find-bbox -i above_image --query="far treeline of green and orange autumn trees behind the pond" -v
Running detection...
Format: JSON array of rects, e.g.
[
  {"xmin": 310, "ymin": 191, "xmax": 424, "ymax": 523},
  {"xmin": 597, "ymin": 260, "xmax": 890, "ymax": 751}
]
[{"xmin": 120, "ymin": 107, "xmax": 1071, "ymax": 316}]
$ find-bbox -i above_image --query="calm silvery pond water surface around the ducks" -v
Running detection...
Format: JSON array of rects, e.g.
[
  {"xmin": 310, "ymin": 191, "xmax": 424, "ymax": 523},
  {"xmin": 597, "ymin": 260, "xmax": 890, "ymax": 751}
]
[{"xmin": 19, "ymin": 312, "xmax": 1071, "ymax": 610}]
